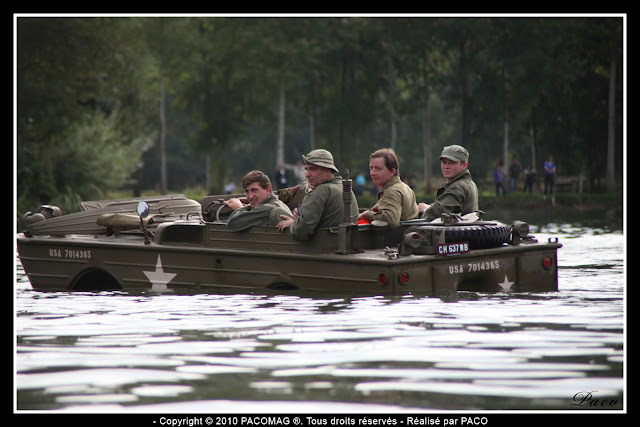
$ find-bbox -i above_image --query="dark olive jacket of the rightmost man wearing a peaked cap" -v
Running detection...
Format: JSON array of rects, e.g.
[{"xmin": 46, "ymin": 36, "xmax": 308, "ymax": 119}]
[{"xmin": 422, "ymin": 170, "xmax": 478, "ymax": 221}]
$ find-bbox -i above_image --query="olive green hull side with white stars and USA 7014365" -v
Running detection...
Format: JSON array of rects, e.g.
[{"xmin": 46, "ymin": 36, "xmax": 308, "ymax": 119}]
[{"xmin": 18, "ymin": 224, "xmax": 561, "ymax": 295}]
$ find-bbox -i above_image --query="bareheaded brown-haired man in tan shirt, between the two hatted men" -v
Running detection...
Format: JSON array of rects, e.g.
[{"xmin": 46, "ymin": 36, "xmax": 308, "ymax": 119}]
[{"xmin": 358, "ymin": 148, "xmax": 418, "ymax": 228}]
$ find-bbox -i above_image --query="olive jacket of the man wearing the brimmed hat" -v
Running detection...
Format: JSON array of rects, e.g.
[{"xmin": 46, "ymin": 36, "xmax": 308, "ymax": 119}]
[{"xmin": 290, "ymin": 176, "xmax": 358, "ymax": 240}]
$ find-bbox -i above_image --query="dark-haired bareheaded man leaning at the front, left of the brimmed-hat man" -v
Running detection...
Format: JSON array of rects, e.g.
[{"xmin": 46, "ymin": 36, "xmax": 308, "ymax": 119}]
[{"xmin": 224, "ymin": 171, "xmax": 293, "ymax": 231}]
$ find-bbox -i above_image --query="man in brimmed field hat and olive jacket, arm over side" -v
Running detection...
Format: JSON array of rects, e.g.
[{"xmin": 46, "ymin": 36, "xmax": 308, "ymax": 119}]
[{"xmin": 278, "ymin": 149, "xmax": 358, "ymax": 240}]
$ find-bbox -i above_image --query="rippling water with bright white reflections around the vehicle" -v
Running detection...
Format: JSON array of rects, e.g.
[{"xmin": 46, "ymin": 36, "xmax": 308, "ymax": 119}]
[{"xmin": 15, "ymin": 212, "xmax": 625, "ymax": 413}]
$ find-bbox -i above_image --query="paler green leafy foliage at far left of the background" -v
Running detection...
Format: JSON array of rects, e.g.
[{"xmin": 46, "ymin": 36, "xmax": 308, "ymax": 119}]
[{"xmin": 16, "ymin": 18, "xmax": 157, "ymax": 213}]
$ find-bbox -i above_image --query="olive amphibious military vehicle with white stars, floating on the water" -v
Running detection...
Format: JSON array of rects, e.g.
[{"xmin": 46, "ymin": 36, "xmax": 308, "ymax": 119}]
[{"xmin": 17, "ymin": 178, "xmax": 562, "ymax": 296}]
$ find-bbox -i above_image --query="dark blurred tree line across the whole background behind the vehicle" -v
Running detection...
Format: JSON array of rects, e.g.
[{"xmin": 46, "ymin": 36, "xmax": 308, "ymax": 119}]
[{"xmin": 14, "ymin": 16, "xmax": 626, "ymax": 212}]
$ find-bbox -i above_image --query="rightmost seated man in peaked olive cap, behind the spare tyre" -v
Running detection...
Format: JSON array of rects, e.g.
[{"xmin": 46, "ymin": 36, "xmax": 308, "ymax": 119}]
[{"xmin": 418, "ymin": 145, "xmax": 478, "ymax": 221}]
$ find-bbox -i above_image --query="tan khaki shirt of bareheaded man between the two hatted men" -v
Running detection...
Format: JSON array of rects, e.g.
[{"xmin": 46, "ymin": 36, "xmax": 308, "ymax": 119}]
[{"xmin": 366, "ymin": 176, "xmax": 420, "ymax": 228}]
